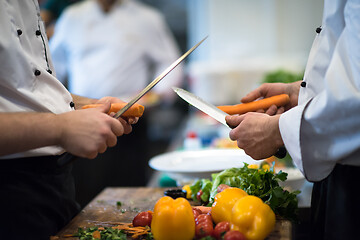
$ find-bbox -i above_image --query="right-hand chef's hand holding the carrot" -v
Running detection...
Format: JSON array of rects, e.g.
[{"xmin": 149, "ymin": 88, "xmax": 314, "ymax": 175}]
[{"xmin": 241, "ymin": 81, "xmax": 301, "ymax": 115}]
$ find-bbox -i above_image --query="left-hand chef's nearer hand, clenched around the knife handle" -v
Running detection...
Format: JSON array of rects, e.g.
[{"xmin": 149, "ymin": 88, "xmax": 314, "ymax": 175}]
[{"xmin": 55, "ymin": 102, "xmax": 132, "ymax": 159}]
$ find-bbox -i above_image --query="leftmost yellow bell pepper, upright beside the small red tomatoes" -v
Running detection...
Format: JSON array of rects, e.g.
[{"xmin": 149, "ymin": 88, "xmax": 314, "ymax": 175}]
[{"xmin": 151, "ymin": 196, "xmax": 195, "ymax": 240}]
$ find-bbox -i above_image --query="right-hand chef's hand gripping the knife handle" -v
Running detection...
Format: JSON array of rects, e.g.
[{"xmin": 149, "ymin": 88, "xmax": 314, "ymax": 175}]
[{"xmin": 225, "ymin": 112, "xmax": 284, "ymax": 160}]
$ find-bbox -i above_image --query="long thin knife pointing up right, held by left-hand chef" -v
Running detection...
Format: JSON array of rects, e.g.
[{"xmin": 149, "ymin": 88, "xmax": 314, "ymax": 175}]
[{"xmin": 57, "ymin": 36, "xmax": 207, "ymax": 166}]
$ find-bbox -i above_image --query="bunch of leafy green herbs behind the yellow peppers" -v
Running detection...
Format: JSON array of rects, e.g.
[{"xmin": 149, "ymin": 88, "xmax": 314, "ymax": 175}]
[{"xmin": 190, "ymin": 163, "xmax": 300, "ymax": 221}]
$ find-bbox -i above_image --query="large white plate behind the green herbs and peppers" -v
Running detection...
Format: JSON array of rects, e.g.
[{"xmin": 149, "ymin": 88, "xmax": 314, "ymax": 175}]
[{"xmin": 149, "ymin": 149, "xmax": 261, "ymax": 186}]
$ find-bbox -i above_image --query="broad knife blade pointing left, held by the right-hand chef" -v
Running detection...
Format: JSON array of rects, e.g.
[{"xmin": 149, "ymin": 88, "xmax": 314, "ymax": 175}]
[{"xmin": 172, "ymin": 87, "xmax": 229, "ymax": 127}]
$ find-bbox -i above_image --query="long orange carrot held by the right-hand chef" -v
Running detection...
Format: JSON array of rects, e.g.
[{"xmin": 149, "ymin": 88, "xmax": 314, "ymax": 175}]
[{"xmin": 218, "ymin": 94, "xmax": 290, "ymax": 115}]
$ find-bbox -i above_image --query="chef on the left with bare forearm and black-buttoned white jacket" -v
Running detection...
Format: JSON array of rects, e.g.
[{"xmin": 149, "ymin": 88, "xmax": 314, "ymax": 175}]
[{"xmin": 0, "ymin": 0, "xmax": 138, "ymax": 240}]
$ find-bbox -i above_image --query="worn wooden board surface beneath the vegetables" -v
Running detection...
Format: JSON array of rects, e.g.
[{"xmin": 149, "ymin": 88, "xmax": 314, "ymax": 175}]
[{"xmin": 56, "ymin": 187, "xmax": 291, "ymax": 240}]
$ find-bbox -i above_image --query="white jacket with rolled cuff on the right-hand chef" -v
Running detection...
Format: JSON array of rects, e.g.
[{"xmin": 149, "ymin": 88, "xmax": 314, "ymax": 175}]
[{"xmin": 279, "ymin": 0, "xmax": 360, "ymax": 181}]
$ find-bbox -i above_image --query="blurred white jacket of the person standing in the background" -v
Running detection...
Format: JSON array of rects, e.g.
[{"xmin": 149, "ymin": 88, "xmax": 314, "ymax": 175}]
[{"xmin": 50, "ymin": 0, "xmax": 183, "ymax": 101}]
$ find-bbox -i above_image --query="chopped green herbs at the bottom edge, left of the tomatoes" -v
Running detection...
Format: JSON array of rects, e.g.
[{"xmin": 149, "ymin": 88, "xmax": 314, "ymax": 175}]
[{"xmin": 74, "ymin": 227, "xmax": 127, "ymax": 240}]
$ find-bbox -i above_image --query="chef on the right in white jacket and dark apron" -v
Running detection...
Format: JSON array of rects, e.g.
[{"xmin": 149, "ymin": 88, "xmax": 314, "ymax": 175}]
[{"xmin": 226, "ymin": 0, "xmax": 360, "ymax": 240}]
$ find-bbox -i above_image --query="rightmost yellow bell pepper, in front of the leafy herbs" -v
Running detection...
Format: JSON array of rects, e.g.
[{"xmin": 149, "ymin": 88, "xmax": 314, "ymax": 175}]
[{"xmin": 230, "ymin": 195, "xmax": 276, "ymax": 240}]
